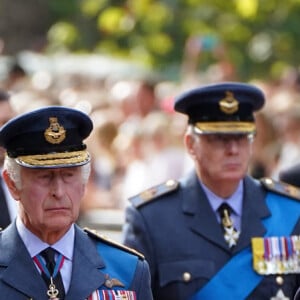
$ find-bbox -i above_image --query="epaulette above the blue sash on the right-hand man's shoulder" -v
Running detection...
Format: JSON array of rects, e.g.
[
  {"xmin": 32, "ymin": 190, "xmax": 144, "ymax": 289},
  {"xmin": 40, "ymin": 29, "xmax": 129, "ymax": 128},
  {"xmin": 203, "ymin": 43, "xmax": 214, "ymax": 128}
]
[{"xmin": 260, "ymin": 178, "xmax": 300, "ymax": 200}]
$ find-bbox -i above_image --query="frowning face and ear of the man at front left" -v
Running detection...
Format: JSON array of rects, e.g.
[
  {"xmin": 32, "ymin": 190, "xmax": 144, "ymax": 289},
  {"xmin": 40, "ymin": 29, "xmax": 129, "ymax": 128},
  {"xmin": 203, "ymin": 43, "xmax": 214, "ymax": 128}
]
[{"xmin": 4, "ymin": 163, "xmax": 85, "ymax": 244}]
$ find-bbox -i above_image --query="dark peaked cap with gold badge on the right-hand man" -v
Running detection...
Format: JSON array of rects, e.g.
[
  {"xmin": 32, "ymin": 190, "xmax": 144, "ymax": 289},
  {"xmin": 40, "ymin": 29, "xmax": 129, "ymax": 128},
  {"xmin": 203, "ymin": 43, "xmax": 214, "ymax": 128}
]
[{"xmin": 175, "ymin": 83, "xmax": 265, "ymax": 134}]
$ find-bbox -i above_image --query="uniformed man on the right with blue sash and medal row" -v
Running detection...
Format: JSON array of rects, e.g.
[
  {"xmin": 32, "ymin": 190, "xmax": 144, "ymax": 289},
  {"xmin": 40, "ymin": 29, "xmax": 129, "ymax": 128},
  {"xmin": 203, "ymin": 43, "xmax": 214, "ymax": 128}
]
[{"xmin": 123, "ymin": 82, "xmax": 300, "ymax": 300}]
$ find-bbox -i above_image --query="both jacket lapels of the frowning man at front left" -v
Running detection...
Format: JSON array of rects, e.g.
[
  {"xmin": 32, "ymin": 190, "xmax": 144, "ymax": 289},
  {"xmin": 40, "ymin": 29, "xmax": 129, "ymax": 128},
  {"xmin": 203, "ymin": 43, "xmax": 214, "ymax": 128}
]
[{"xmin": 0, "ymin": 223, "xmax": 105, "ymax": 300}]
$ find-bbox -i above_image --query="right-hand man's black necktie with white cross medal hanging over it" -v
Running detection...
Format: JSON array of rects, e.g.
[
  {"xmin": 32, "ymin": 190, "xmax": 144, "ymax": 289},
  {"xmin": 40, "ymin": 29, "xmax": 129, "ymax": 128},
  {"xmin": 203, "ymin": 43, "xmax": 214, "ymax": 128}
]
[{"xmin": 218, "ymin": 203, "xmax": 240, "ymax": 248}]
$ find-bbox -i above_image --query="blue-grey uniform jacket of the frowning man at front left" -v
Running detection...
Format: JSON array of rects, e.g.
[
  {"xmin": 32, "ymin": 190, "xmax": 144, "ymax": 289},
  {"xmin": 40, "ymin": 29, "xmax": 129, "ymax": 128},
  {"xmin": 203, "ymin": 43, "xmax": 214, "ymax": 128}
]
[{"xmin": 0, "ymin": 223, "xmax": 152, "ymax": 300}]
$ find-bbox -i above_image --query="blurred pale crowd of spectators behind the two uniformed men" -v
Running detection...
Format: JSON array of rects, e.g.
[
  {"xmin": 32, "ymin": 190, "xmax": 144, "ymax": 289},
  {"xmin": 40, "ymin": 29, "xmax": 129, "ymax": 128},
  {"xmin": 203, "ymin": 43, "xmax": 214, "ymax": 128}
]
[{"xmin": 0, "ymin": 51, "xmax": 300, "ymax": 220}]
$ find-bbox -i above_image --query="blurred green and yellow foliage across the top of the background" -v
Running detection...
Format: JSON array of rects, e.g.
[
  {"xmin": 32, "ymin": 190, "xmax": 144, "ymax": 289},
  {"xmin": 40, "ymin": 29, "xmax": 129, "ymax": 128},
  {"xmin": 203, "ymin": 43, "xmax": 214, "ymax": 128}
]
[{"xmin": 48, "ymin": 0, "xmax": 300, "ymax": 80}]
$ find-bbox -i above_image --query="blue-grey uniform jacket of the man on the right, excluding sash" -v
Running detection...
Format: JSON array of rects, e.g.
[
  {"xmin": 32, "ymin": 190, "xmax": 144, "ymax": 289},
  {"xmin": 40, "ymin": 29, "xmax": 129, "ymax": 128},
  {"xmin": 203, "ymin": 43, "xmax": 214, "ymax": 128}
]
[{"xmin": 123, "ymin": 172, "xmax": 300, "ymax": 300}]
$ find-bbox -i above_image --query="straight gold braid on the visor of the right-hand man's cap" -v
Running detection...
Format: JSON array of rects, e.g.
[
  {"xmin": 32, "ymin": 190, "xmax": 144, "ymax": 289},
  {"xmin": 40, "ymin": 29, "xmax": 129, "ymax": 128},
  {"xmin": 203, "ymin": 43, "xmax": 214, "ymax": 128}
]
[{"xmin": 194, "ymin": 121, "xmax": 256, "ymax": 133}]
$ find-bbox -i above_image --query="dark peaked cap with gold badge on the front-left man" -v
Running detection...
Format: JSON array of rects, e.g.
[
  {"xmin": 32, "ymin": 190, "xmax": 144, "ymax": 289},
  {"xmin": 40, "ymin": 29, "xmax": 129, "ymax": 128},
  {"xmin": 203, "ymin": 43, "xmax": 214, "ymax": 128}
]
[{"xmin": 0, "ymin": 106, "xmax": 93, "ymax": 168}]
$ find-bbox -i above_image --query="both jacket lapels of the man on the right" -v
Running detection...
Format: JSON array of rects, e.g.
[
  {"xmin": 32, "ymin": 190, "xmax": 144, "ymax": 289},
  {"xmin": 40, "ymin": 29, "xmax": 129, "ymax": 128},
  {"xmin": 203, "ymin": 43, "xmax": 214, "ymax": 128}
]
[{"xmin": 181, "ymin": 173, "xmax": 270, "ymax": 252}]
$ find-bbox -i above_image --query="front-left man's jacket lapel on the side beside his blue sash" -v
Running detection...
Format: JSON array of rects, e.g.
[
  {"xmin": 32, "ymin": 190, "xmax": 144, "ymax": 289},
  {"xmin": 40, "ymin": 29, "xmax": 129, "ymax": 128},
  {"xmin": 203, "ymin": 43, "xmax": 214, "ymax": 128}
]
[{"xmin": 65, "ymin": 226, "xmax": 105, "ymax": 300}]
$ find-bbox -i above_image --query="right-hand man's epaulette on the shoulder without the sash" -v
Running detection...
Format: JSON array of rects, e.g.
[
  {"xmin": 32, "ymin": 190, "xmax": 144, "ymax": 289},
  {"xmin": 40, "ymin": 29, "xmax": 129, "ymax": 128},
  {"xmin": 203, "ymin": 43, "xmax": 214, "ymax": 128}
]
[{"xmin": 129, "ymin": 179, "xmax": 179, "ymax": 207}]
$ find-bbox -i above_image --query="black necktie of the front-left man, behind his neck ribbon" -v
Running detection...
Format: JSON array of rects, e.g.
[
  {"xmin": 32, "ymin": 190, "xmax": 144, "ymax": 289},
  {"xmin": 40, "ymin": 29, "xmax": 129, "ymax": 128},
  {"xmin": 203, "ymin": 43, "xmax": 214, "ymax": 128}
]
[{"xmin": 41, "ymin": 247, "xmax": 65, "ymax": 299}]
